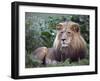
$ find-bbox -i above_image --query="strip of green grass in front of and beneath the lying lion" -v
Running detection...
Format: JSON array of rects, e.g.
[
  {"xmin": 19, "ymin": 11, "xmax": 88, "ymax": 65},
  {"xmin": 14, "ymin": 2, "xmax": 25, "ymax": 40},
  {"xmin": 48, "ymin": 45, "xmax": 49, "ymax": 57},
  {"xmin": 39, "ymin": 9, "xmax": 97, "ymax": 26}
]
[{"xmin": 25, "ymin": 55, "xmax": 89, "ymax": 68}]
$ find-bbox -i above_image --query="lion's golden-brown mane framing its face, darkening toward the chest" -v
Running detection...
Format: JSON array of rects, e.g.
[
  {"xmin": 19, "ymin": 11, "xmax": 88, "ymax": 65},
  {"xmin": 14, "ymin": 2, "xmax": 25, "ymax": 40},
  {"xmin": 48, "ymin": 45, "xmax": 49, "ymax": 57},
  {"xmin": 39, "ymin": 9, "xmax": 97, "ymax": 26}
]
[{"xmin": 53, "ymin": 21, "xmax": 86, "ymax": 60}]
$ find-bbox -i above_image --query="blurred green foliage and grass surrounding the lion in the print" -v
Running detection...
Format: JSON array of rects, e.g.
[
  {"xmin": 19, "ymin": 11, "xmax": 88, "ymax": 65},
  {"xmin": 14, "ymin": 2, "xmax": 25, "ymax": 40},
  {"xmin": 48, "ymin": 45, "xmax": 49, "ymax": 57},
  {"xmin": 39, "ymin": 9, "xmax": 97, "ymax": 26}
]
[{"xmin": 25, "ymin": 12, "xmax": 89, "ymax": 68}]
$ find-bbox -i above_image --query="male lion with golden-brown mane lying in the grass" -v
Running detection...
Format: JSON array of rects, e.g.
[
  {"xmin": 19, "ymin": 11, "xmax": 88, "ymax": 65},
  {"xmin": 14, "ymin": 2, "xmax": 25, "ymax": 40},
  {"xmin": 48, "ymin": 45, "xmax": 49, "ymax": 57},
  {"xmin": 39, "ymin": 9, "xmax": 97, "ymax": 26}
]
[{"xmin": 33, "ymin": 21, "xmax": 87, "ymax": 64}]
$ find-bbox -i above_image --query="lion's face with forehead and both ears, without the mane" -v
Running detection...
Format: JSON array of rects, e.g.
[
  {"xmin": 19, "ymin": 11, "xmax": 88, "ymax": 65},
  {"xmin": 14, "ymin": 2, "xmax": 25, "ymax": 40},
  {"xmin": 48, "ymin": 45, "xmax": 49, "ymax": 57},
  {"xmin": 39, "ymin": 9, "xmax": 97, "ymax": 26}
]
[{"xmin": 57, "ymin": 22, "xmax": 79, "ymax": 48}]
